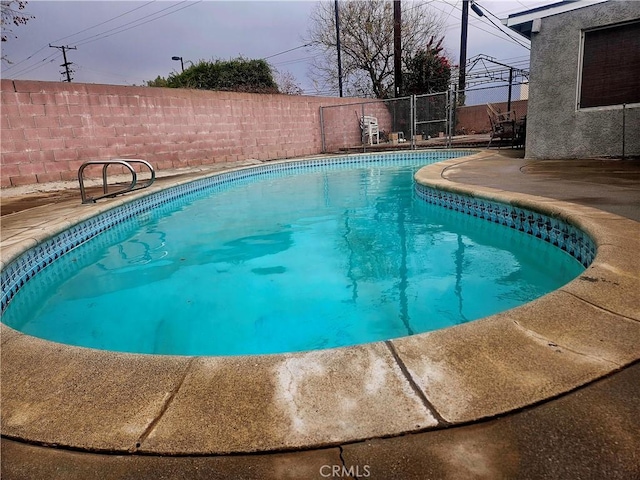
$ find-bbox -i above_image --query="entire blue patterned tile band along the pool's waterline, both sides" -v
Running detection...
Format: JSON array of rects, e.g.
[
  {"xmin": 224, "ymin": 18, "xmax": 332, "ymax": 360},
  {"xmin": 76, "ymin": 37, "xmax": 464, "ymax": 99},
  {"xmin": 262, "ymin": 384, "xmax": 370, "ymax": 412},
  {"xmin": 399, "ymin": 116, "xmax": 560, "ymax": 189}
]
[{"xmin": 0, "ymin": 150, "xmax": 596, "ymax": 312}]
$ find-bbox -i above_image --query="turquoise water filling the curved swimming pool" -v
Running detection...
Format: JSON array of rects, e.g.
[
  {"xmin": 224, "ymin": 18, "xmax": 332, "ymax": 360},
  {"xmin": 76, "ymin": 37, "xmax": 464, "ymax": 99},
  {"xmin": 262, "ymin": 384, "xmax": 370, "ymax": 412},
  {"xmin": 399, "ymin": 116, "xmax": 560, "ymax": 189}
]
[{"xmin": 2, "ymin": 159, "xmax": 584, "ymax": 355}]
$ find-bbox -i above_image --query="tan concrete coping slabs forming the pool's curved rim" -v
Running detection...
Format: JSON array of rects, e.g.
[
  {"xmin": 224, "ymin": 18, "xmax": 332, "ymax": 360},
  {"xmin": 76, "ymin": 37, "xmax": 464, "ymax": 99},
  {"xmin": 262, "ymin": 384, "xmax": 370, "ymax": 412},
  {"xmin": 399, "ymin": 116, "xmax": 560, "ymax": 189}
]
[{"xmin": 2, "ymin": 152, "xmax": 640, "ymax": 455}]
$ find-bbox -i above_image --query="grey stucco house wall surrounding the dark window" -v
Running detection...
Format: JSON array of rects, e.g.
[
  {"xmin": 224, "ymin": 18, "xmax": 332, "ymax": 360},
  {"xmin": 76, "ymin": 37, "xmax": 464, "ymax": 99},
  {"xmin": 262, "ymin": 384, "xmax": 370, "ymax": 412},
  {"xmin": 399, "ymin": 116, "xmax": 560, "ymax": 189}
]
[{"xmin": 525, "ymin": 1, "xmax": 640, "ymax": 159}]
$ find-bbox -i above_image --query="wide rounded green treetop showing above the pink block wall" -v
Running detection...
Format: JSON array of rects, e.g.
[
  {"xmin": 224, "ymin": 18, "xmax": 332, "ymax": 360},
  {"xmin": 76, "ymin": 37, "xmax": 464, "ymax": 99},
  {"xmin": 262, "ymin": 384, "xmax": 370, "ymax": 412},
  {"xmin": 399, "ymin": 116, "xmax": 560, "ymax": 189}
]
[{"xmin": 146, "ymin": 57, "xmax": 278, "ymax": 93}]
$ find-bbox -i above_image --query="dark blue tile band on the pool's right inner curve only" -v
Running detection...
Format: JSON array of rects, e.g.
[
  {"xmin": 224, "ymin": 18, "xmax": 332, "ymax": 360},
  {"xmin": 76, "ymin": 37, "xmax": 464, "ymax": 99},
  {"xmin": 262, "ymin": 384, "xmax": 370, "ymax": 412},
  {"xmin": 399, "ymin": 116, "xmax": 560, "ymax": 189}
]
[{"xmin": 415, "ymin": 183, "xmax": 596, "ymax": 268}]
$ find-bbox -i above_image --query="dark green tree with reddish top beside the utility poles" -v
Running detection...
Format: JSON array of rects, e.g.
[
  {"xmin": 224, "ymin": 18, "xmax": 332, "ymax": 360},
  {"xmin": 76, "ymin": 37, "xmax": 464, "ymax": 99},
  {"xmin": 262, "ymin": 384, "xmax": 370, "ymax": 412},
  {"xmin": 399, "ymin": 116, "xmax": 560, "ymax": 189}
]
[{"xmin": 403, "ymin": 39, "xmax": 451, "ymax": 95}]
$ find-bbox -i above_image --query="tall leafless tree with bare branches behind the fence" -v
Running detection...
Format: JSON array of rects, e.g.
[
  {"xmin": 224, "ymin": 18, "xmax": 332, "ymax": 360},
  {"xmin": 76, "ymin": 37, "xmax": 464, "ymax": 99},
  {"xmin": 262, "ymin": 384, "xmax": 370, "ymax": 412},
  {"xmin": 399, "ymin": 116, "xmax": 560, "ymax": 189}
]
[{"xmin": 306, "ymin": 0, "xmax": 444, "ymax": 98}]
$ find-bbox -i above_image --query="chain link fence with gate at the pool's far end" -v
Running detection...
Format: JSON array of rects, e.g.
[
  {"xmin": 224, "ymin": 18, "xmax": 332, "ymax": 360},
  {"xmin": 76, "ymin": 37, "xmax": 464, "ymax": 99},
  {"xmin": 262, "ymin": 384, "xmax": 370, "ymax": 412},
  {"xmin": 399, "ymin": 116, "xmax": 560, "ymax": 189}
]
[{"xmin": 320, "ymin": 83, "xmax": 528, "ymax": 153}]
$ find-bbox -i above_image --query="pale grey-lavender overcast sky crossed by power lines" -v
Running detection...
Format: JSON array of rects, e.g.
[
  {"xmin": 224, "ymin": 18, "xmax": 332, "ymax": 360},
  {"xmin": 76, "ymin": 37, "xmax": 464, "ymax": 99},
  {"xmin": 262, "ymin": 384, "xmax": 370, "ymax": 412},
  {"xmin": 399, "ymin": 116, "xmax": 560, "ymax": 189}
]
[{"xmin": 2, "ymin": 0, "xmax": 580, "ymax": 95}]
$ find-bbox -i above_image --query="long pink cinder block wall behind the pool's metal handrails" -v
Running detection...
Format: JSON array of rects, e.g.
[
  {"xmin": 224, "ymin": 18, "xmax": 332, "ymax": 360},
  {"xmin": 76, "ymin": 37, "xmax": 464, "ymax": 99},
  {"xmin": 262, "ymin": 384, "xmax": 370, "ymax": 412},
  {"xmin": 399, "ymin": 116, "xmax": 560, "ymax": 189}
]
[{"xmin": 0, "ymin": 79, "xmax": 372, "ymax": 187}]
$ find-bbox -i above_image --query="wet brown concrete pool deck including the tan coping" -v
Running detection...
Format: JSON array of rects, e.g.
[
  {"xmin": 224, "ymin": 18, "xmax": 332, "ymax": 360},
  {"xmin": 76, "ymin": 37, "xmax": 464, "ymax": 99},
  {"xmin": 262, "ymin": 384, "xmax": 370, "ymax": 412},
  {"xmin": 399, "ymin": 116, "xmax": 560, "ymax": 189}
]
[{"xmin": 2, "ymin": 151, "xmax": 640, "ymax": 478}]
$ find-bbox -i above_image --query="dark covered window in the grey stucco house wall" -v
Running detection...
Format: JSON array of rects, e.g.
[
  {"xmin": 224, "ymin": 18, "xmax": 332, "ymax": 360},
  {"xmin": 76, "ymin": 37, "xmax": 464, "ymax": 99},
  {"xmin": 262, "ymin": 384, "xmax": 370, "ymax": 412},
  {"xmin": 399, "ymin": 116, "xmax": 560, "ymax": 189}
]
[{"xmin": 578, "ymin": 22, "xmax": 640, "ymax": 108}]
